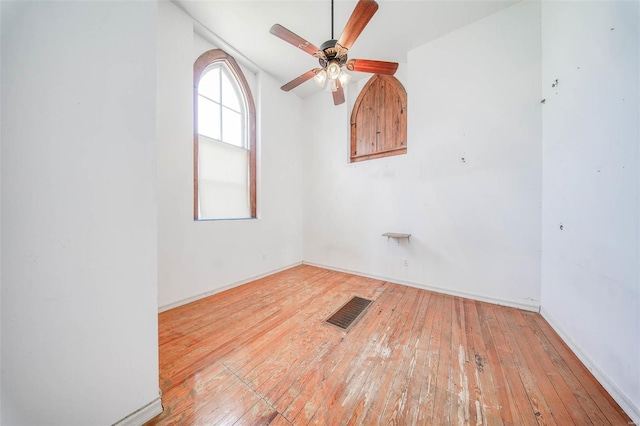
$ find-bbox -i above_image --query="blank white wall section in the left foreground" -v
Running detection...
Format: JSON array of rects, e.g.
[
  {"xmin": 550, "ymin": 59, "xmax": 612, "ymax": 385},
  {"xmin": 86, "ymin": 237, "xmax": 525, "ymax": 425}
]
[{"xmin": 1, "ymin": 1, "xmax": 158, "ymax": 426}]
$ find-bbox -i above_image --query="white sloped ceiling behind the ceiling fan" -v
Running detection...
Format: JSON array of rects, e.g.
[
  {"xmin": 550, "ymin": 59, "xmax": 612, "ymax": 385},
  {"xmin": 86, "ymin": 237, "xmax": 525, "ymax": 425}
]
[{"xmin": 174, "ymin": 0, "xmax": 518, "ymax": 98}]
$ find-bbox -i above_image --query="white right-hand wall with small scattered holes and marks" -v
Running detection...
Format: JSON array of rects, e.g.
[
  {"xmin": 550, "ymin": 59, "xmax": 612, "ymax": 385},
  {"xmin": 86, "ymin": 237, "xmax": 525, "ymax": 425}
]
[{"xmin": 542, "ymin": 1, "xmax": 640, "ymax": 422}]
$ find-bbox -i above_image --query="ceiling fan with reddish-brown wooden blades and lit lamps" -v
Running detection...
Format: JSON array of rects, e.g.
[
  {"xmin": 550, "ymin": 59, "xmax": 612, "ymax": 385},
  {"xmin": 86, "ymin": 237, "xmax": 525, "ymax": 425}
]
[{"xmin": 269, "ymin": 0, "xmax": 398, "ymax": 105}]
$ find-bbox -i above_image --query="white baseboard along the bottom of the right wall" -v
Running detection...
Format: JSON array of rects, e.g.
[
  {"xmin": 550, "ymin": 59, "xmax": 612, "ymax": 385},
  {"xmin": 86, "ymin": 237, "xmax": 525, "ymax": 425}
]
[{"xmin": 540, "ymin": 308, "xmax": 640, "ymax": 425}]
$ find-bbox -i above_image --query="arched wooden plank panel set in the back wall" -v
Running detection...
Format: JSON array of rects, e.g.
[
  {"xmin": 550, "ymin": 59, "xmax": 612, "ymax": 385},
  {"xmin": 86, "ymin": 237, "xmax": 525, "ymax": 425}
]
[{"xmin": 351, "ymin": 74, "xmax": 407, "ymax": 162}]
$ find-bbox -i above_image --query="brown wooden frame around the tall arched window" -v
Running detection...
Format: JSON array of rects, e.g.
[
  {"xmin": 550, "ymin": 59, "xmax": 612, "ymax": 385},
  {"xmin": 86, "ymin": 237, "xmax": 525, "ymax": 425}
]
[{"xmin": 193, "ymin": 49, "xmax": 257, "ymax": 220}]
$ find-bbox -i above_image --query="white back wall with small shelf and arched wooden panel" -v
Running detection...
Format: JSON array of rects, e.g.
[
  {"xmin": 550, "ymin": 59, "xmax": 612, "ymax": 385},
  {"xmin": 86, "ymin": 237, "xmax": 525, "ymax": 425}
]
[{"xmin": 304, "ymin": 2, "xmax": 541, "ymax": 309}]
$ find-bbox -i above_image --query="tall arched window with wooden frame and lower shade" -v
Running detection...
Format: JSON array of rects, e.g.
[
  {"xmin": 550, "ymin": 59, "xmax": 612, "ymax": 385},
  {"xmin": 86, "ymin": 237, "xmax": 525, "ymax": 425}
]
[{"xmin": 193, "ymin": 49, "xmax": 256, "ymax": 220}]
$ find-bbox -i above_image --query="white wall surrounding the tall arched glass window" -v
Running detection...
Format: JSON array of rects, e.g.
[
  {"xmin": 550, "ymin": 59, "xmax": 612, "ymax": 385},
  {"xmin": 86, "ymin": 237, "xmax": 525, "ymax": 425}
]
[{"xmin": 157, "ymin": 2, "xmax": 302, "ymax": 309}]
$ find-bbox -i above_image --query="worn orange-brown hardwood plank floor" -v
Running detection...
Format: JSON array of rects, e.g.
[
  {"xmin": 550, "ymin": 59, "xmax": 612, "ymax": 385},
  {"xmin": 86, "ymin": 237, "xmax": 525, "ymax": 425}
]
[{"xmin": 148, "ymin": 265, "xmax": 631, "ymax": 426}]
